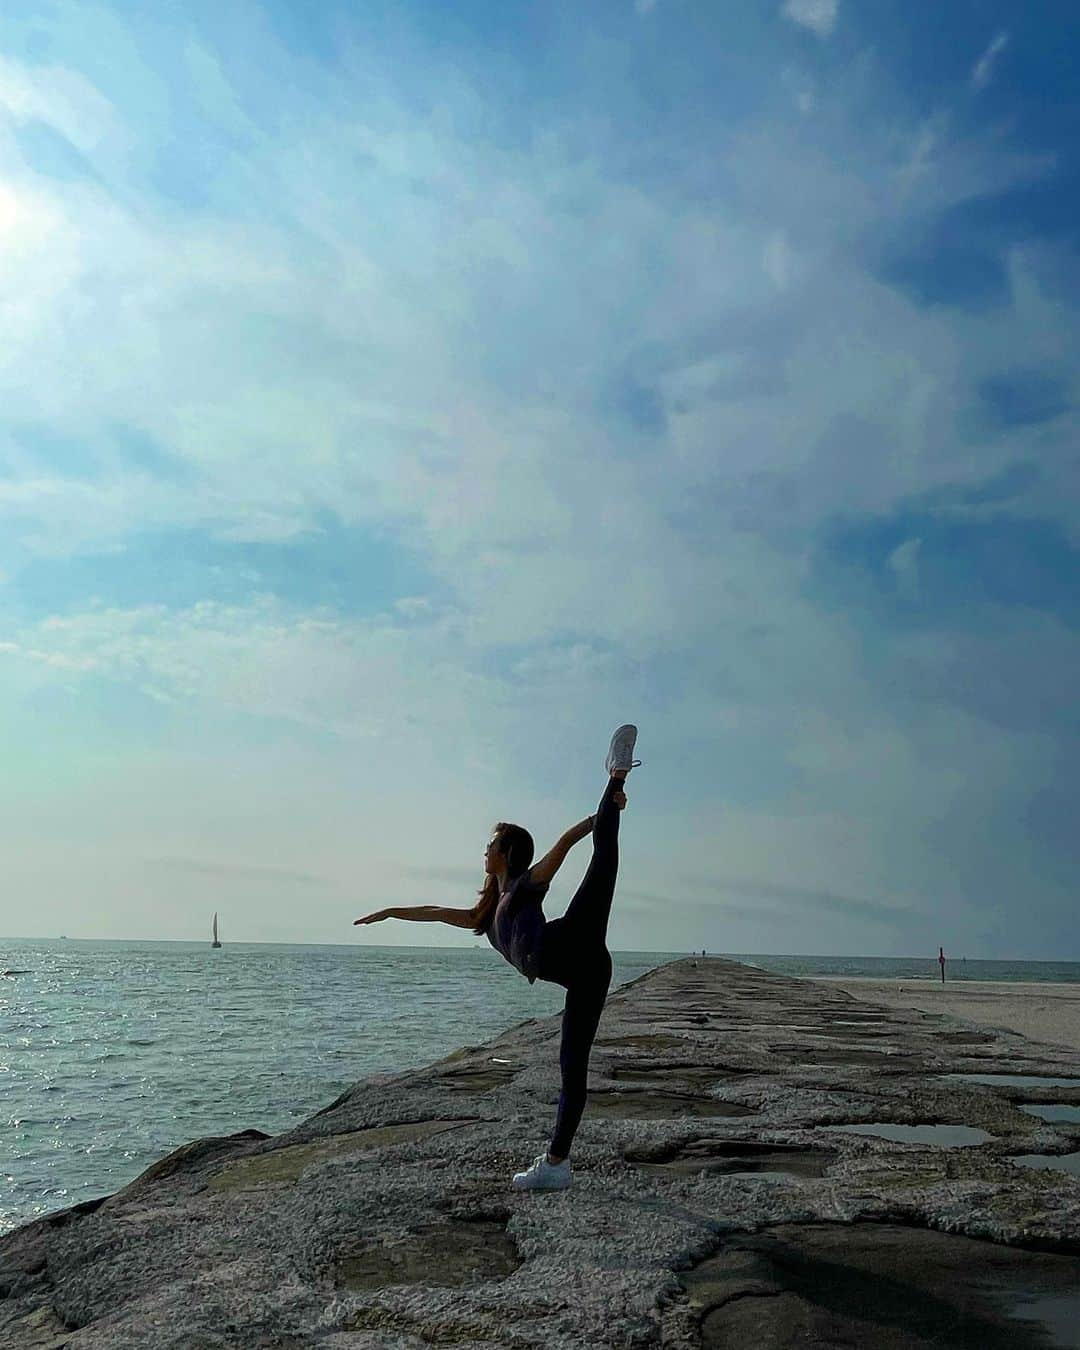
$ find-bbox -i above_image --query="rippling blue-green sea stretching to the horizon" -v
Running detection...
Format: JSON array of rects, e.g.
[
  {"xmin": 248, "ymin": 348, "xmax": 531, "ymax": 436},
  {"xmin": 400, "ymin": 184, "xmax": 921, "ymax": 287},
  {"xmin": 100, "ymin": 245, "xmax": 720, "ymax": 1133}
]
[{"xmin": 0, "ymin": 940, "xmax": 1080, "ymax": 1233}]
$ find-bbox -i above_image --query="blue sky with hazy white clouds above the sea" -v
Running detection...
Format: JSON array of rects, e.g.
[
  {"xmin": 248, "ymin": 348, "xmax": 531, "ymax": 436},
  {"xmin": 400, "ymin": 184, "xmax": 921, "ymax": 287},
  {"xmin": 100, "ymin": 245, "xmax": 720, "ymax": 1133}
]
[{"xmin": 0, "ymin": 0, "xmax": 1080, "ymax": 960}]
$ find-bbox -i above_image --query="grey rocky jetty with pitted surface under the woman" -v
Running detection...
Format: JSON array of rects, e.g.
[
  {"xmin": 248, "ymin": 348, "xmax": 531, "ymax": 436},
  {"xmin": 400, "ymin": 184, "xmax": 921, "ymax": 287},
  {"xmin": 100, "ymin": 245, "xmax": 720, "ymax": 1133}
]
[{"xmin": 0, "ymin": 959, "xmax": 1080, "ymax": 1350}]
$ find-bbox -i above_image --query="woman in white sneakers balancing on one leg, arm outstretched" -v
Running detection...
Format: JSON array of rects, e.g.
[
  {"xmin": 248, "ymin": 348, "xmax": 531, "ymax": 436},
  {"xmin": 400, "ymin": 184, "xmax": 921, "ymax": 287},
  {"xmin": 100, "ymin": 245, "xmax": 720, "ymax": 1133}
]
[{"xmin": 356, "ymin": 726, "xmax": 640, "ymax": 1191}]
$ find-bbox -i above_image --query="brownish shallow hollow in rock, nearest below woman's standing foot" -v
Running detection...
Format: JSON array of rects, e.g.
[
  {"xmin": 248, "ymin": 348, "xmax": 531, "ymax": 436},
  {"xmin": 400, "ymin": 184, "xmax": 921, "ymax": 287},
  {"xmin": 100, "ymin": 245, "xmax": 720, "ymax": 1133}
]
[{"xmin": 335, "ymin": 1219, "xmax": 521, "ymax": 1289}]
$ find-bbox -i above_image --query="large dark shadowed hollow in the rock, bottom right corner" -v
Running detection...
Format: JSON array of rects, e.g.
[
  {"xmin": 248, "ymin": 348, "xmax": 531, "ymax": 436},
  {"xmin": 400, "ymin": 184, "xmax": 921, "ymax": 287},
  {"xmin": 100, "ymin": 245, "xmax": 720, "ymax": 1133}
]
[{"xmin": 679, "ymin": 1223, "xmax": 1080, "ymax": 1350}]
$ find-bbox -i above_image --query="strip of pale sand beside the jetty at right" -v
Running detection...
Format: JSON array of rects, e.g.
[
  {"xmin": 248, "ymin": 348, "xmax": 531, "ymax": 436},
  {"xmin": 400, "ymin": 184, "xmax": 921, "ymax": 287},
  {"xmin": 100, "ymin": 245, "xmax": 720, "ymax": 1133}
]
[{"xmin": 811, "ymin": 976, "xmax": 1080, "ymax": 1050}]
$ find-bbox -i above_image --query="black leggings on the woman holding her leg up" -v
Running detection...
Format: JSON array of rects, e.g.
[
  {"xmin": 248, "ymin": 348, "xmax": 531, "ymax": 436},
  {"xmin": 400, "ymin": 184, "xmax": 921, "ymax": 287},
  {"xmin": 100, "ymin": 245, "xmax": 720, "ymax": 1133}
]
[{"xmin": 537, "ymin": 778, "xmax": 622, "ymax": 1158}]
